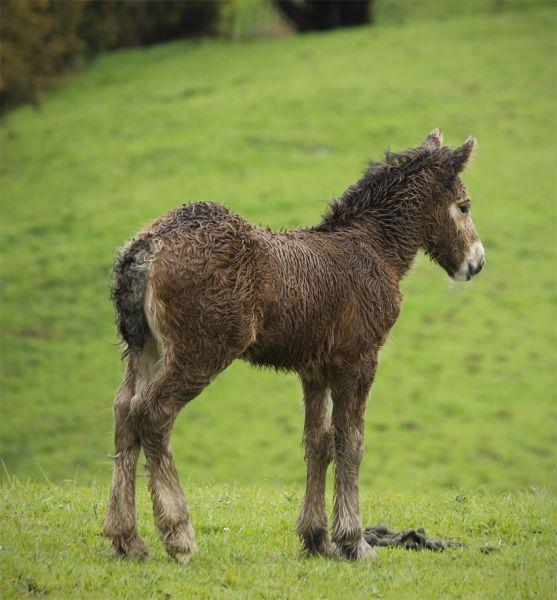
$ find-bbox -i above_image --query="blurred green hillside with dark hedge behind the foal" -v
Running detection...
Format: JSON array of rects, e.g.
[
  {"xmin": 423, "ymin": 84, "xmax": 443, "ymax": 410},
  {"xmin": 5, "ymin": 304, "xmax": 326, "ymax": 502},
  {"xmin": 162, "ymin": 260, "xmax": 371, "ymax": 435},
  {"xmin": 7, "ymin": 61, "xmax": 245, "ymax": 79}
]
[{"xmin": 0, "ymin": 0, "xmax": 557, "ymax": 491}]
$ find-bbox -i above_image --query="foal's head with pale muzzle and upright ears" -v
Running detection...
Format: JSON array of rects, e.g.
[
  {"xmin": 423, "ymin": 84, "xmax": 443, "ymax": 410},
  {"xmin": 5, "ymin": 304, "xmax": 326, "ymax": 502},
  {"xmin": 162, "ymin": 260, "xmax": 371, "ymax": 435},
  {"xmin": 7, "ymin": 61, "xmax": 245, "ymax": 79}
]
[{"xmin": 423, "ymin": 129, "xmax": 485, "ymax": 281}]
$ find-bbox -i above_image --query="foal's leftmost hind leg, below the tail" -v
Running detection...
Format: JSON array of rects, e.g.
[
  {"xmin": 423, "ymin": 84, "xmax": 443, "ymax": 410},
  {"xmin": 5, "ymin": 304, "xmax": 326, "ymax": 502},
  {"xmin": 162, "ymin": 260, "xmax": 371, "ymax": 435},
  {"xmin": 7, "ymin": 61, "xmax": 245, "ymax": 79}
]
[{"xmin": 104, "ymin": 357, "xmax": 147, "ymax": 558}]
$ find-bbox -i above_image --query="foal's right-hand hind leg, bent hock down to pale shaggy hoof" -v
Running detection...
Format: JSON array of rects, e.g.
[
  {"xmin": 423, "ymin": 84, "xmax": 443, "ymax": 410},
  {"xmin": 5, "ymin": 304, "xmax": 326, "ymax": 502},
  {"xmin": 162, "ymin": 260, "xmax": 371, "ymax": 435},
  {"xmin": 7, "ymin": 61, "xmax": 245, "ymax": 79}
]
[{"xmin": 133, "ymin": 365, "xmax": 209, "ymax": 562}]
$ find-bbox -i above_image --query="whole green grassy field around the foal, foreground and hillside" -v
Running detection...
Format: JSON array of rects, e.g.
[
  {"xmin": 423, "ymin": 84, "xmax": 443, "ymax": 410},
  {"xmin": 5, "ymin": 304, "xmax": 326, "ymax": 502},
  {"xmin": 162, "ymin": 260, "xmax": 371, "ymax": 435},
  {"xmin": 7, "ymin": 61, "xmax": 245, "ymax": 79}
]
[{"xmin": 0, "ymin": 2, "xmax": 557, "ymax": 598}]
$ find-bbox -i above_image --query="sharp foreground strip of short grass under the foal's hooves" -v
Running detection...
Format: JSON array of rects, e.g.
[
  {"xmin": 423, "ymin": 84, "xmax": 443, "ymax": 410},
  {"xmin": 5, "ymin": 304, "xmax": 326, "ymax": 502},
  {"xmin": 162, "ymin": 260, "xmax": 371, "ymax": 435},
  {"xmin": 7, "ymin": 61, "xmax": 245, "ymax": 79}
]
[{"xmin": 0, "ymin": 482, "xmax": 557, "ymax": 600}]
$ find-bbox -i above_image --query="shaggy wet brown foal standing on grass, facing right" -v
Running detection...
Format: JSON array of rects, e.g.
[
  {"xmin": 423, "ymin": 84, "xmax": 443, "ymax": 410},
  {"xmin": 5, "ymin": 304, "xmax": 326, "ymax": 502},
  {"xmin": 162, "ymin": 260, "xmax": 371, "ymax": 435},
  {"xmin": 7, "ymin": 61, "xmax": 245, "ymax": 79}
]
[{"xmin": 104, "ymin": 130, "xmax": 484, "ymax": 562}]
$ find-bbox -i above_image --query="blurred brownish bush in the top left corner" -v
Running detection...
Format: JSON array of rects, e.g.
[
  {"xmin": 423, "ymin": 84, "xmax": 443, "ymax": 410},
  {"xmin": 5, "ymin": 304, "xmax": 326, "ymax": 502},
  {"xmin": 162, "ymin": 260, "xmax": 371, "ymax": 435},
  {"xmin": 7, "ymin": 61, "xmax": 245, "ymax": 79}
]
[{"xmin": 0, "ymin": 0, "xmax": 223, "ymax": 111}]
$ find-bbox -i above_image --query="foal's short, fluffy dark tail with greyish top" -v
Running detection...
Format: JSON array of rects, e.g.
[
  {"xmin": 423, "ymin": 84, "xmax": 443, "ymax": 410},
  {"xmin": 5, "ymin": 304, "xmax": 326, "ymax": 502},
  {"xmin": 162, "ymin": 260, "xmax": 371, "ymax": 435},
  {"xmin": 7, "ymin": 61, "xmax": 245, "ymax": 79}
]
[{"xmin": 112, "ymin": 237, "xmax": 152, "ymax": 356}]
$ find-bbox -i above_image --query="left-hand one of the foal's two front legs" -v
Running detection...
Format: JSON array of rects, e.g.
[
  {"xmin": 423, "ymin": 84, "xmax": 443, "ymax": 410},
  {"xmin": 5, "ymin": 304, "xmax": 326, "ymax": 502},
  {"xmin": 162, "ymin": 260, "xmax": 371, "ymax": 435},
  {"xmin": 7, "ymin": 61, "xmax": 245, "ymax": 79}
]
[{"xmin": 296, "ymin": 377, "xmax": 334, "ymax": 556}]
